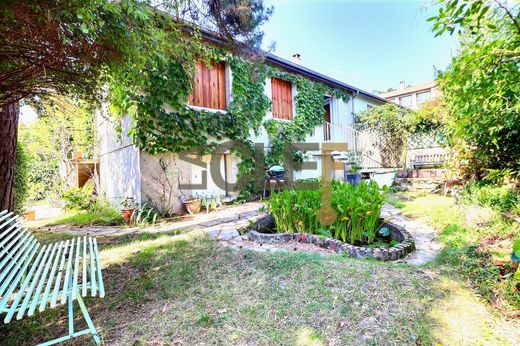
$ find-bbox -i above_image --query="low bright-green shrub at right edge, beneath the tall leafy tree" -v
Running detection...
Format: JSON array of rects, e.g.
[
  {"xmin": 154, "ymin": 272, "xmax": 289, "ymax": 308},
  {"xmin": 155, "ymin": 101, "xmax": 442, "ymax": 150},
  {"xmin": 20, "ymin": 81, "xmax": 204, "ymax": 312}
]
[{"xmin": 462, "ymin": 183, "xmax": 520, "ymax": 212}]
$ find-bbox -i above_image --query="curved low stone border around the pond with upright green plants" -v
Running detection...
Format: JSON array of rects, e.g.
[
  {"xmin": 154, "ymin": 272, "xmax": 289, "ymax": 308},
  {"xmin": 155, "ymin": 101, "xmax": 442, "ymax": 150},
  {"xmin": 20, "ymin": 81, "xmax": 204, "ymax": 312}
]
[{"xmin": 247, "ymin": 215, "xmax": 415, "ymax": 261}]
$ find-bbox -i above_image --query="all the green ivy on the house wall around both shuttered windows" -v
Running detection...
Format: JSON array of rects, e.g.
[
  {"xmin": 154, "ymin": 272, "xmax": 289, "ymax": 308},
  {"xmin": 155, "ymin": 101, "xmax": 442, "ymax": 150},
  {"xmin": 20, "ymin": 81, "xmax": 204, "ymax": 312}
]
[{"xmin": 111, "ymin": 47, "xmax": 350, "ymax": 198}]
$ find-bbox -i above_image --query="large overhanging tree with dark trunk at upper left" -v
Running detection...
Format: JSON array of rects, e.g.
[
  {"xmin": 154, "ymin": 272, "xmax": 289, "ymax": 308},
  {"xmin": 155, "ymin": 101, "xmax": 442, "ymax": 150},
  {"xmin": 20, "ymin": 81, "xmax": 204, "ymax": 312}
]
[{"xmin": 0, "ymin": 0, "xmax": 270, "ymax": 210}]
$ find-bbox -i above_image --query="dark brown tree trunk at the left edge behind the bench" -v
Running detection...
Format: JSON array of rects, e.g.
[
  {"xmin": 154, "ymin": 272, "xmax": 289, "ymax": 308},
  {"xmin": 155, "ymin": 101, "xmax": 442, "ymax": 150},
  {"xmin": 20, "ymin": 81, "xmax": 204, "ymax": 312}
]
[{"xmin": 0, "ymin": 104, "xmax": 19, "ymax": 211}]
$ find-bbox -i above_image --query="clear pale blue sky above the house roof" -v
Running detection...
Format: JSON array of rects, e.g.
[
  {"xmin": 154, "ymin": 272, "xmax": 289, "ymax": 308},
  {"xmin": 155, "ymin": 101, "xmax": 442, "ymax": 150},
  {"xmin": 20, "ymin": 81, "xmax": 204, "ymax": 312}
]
[{"xmin": 263, "ymin": 0, "xmax": 456, "ymax": 91}]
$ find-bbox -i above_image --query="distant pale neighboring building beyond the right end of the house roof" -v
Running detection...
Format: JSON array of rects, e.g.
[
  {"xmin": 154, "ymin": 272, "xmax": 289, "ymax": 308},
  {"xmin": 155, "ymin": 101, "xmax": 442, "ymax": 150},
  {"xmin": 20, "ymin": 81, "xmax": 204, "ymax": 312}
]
[{"xmin": 379, "ymin": 81, "xmax": 440, "ymax": 110}]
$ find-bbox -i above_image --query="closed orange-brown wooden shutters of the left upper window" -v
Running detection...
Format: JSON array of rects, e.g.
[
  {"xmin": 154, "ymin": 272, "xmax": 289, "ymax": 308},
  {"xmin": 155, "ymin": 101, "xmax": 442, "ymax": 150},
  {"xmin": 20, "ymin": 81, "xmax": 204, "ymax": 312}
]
[{"xmin": 189, "ymin": 61, "xmax": 227, "ymax": 110}]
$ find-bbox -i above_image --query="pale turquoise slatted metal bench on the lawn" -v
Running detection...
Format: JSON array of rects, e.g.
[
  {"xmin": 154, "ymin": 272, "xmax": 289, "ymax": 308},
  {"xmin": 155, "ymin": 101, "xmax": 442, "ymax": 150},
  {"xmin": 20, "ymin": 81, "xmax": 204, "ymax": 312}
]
[{"xmin": 0, "ymin": 211, "xmax": 105, "ymax": 345}]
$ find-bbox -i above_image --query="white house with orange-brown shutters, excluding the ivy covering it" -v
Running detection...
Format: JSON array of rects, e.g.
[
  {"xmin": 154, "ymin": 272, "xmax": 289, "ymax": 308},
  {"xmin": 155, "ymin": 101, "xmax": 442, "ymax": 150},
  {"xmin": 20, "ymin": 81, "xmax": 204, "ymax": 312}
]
[{"xmin": 96, "ymin": 46, "xmax": 387, "ymax": 213}]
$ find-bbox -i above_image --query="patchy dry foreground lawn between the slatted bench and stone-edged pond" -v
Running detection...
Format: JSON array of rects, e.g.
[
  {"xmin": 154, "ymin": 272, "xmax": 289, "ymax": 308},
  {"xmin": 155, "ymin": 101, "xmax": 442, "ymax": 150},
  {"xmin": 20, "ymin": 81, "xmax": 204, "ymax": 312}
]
[{"xmin": 0, "ymin": 227, "xmax": 517, "ymax": 345}]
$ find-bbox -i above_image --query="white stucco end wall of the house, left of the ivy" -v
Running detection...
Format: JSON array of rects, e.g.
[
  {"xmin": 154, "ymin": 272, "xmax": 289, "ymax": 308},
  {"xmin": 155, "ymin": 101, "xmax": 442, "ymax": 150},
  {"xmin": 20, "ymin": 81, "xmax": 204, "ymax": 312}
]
[{"xmin": 96, "ymin": 108, "xmax": 141, "ymax": 205}]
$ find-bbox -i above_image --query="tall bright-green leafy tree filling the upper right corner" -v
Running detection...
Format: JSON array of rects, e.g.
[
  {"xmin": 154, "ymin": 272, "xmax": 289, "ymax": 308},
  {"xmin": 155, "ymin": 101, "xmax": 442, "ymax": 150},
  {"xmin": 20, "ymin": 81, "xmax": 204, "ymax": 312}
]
[{"xmin": 430, "ymin": 0, "xmax": 520, "ymax": 179}]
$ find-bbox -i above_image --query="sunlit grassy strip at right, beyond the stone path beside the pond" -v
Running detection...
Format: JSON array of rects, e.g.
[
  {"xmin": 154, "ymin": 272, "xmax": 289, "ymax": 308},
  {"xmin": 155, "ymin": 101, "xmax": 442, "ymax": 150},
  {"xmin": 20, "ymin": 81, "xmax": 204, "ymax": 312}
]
[{"xmin": 390, "ymin": 194, "xmax": 520, "ymax": 317}]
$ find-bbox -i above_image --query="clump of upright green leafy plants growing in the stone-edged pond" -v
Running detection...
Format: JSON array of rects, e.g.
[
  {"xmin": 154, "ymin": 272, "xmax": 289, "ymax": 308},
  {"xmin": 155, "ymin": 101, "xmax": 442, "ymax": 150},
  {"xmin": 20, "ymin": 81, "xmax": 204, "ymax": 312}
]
[{"xmin": 267, "ymin": 181, "xmax": 385, "ymax": 244}]
